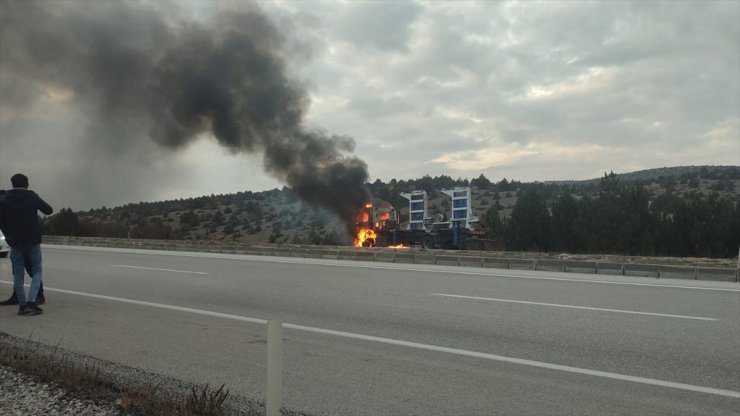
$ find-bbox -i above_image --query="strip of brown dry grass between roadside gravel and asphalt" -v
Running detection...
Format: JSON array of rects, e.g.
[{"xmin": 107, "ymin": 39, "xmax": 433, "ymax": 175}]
[{"xmin": 0, "ymin": 334, "xmax": 232, "ymax": 416}]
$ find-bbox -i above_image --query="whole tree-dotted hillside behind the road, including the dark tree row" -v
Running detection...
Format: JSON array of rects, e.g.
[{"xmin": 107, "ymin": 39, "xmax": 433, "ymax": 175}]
[{"xmin": 45, "ymin": 166, "xmax": 740, "ymax": 258}]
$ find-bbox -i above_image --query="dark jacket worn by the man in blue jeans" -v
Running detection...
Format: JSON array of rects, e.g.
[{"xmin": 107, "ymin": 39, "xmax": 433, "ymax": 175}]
[{"xmin": 0, "ymin": 188, "xmax": 54, "ymax": 247}]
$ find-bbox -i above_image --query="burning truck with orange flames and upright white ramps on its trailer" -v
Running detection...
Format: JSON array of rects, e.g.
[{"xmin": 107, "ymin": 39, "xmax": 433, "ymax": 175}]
[{"xmin": 354, "ymin": 187, "xmax": 493, "ymax": 250}]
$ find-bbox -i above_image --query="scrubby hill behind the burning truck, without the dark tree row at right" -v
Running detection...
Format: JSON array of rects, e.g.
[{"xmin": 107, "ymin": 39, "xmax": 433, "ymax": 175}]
[{"xmin": 45, "ymin": 166, "xmax": 740, "ymax": 254}]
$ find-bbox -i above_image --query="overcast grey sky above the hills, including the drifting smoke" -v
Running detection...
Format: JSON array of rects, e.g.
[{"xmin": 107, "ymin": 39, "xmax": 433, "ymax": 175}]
[{"xmin": 0, "ymin": 0, "xmax": 740, "ymax": 210}]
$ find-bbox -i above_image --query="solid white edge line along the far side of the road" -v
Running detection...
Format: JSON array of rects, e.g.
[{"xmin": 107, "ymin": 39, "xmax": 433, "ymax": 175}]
[{"xmin": 48, "ymin": 245, "xmax": 740, "ymax": 292}]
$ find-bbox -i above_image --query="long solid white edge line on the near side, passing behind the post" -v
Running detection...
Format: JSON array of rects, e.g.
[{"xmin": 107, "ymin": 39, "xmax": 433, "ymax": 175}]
[{"xmin": 0, "ymin": 281, "xmax": 740, "ymax": 399}]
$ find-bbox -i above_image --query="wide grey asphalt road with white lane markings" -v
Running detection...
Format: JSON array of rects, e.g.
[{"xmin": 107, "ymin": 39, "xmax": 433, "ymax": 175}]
[{"xmin": 0, "ymin": 246, "xmax": 740, "ymax": 415}]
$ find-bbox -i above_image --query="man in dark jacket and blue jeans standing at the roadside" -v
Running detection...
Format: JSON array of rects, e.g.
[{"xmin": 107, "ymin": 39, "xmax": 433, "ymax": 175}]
[{"xmin": 0, "ymin": 173, "xmax": 54, "ymax": 315}]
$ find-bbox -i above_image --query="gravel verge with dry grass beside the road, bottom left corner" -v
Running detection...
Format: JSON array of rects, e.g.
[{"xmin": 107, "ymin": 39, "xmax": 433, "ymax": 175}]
[{"xmin": 0, "ymin": 332, "xmax": 311, "ymax": 416}]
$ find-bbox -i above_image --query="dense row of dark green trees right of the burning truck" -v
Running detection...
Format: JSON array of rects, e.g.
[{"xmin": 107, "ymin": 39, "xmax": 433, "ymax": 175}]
[{"xmin": 484, "ymin": 174, "xmax": 740, "ymax": 258}]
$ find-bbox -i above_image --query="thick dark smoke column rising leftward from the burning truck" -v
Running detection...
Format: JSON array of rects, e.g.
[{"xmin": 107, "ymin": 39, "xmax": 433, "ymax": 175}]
[{"xmin": 0, "ymin": 0, "xmax": 368, "ymax": 229}]
